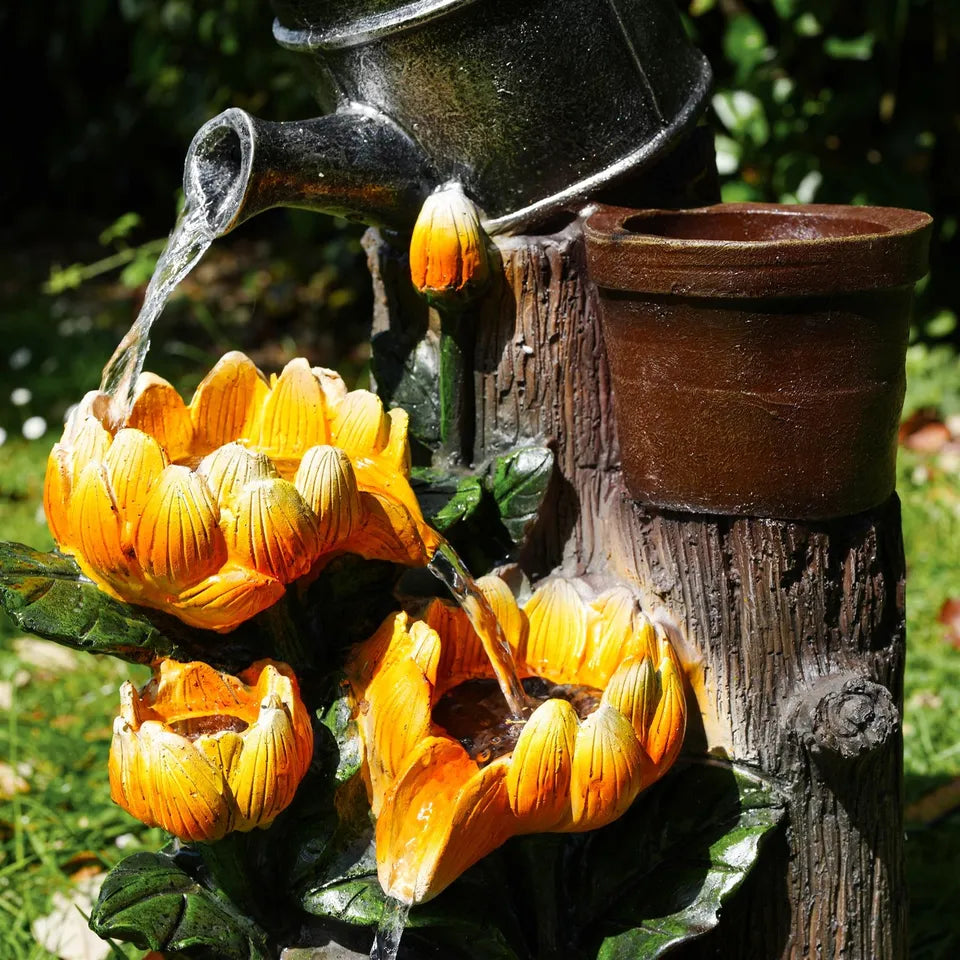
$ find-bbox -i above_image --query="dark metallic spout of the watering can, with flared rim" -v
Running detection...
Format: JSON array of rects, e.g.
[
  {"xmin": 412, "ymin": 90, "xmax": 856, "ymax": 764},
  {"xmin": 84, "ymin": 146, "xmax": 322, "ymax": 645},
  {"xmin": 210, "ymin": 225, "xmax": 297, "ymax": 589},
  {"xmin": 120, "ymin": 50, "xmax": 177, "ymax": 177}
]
[{"xmin": 183, "ymin": 106, "xmax": 434, "ymax": 236}]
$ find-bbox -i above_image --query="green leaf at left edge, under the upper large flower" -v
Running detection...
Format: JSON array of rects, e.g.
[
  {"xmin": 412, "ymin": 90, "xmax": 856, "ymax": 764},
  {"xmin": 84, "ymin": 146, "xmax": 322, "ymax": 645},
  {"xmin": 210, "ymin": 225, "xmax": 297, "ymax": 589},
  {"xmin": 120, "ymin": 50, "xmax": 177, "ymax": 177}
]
[{"xmin": 0, "ymin": 543, "xmax": 175, "ymax": 663}]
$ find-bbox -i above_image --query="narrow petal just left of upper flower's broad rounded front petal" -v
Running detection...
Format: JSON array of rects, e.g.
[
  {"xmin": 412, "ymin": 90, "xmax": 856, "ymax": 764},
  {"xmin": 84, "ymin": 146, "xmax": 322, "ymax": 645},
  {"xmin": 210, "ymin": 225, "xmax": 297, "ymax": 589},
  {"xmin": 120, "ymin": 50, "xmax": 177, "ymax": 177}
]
[{"xmin": 69, "ymin": 461, "xmax": 135, "ymax": 581}]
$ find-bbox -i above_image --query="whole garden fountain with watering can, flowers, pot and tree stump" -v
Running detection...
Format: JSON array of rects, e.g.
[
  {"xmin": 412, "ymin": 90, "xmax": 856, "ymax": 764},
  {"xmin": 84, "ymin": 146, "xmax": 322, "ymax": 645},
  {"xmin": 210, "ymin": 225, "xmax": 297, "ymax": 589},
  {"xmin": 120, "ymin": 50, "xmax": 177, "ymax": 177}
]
[{"xmin": 4, "ymin": 0, "xmax": 929, "ymax": 960}]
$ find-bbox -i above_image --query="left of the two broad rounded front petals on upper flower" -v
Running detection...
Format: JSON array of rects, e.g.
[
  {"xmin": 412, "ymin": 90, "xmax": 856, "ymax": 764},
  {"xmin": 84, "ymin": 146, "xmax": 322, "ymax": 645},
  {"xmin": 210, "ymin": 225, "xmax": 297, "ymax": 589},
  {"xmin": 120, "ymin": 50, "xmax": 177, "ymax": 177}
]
[{"xmin": 135, "ymin": 465, "xmax": 227, "ymax": 595}]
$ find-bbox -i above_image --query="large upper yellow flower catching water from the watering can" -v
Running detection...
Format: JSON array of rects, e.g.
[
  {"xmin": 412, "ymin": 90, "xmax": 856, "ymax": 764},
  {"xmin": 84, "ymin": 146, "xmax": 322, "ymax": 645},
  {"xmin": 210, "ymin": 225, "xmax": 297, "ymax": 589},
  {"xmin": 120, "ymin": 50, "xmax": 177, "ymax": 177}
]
[{"xmin": 44, "ymin": 353, "xmax": 438, "ymax": 631}]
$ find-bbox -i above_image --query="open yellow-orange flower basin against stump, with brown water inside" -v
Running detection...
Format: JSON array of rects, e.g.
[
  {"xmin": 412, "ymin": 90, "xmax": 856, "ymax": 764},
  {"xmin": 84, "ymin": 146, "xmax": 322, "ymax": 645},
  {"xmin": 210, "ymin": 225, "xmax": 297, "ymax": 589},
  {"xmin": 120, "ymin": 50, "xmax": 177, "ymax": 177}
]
[{"xmin": 348, "ymin": 577, "xmax": 685, "ymax": 903}]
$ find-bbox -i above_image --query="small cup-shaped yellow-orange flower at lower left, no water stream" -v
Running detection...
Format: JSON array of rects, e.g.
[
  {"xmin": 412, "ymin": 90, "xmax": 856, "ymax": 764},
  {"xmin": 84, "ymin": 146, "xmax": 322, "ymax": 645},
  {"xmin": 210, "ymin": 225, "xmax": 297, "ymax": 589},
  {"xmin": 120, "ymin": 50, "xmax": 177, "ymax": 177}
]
[{"xmin": 110, "ymin": 660, "xmax": 313, "ymax": 842}]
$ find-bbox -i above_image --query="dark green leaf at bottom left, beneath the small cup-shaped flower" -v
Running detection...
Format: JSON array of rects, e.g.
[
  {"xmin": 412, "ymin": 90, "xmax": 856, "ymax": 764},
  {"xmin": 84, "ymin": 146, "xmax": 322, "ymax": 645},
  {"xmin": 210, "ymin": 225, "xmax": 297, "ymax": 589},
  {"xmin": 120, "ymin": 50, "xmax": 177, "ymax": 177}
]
[{"xmin": 90, "ymin": 853, "xmax": 273, "ymax": 960}]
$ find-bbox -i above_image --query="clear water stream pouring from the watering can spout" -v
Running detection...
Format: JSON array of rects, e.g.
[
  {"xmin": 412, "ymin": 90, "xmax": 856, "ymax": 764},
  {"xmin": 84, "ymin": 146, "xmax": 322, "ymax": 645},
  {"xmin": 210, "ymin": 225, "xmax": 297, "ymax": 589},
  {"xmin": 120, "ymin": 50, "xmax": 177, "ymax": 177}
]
[{"xmin": 100, "ymin": 206, "xmax": 215, "ymax": 416}]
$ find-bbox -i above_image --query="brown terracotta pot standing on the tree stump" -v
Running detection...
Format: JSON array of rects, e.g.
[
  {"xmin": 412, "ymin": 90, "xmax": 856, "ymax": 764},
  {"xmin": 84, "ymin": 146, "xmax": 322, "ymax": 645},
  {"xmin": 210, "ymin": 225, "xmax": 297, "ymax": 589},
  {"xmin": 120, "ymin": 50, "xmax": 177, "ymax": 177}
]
[{"xmin": 585, "ymin": 203, "xmax": 931, "ymax": 519}]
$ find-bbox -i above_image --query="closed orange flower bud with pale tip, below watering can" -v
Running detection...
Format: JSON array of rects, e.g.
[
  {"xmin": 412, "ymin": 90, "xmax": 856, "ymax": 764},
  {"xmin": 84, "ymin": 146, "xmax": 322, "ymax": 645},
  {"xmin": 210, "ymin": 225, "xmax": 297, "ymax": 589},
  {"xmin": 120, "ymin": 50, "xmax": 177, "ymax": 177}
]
[{"xmin": 410, "ymin": 182, "xmax": 490, "ymax": 299}]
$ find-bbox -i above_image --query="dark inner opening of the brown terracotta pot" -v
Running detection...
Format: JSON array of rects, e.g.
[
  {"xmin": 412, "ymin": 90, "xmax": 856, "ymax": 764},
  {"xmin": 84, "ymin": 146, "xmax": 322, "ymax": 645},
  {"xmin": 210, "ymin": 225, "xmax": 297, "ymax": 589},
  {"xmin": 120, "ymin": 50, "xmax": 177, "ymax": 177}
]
[{"xmin": 623, "ymin": 208, "xmax": 890, "ymax": 242}]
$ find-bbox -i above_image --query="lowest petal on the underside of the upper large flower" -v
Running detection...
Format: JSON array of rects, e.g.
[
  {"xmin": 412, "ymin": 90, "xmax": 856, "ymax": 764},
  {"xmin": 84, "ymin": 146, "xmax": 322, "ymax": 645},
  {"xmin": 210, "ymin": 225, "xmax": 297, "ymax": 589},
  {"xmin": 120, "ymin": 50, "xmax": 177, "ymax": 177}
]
[{"xmin": 171, "ymin": 563, "xmax": 284, "ymax": 633}]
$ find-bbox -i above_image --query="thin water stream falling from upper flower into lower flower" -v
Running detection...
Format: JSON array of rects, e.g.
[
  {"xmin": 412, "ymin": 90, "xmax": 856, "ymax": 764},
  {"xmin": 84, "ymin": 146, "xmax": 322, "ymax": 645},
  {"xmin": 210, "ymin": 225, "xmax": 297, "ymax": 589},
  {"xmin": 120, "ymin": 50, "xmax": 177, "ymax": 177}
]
[{"xmin": 427, "ymin": 541, "xmax": 530, "ymax": 720}]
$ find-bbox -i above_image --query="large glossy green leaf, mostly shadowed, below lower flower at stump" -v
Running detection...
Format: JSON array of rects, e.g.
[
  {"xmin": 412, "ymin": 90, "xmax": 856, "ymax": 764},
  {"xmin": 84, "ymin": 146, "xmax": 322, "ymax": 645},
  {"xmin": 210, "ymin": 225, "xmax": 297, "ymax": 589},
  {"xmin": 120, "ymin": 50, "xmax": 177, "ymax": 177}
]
[{"xmin": 575, "ymin": 762, "xmax": 784, "ymax": 960}]
